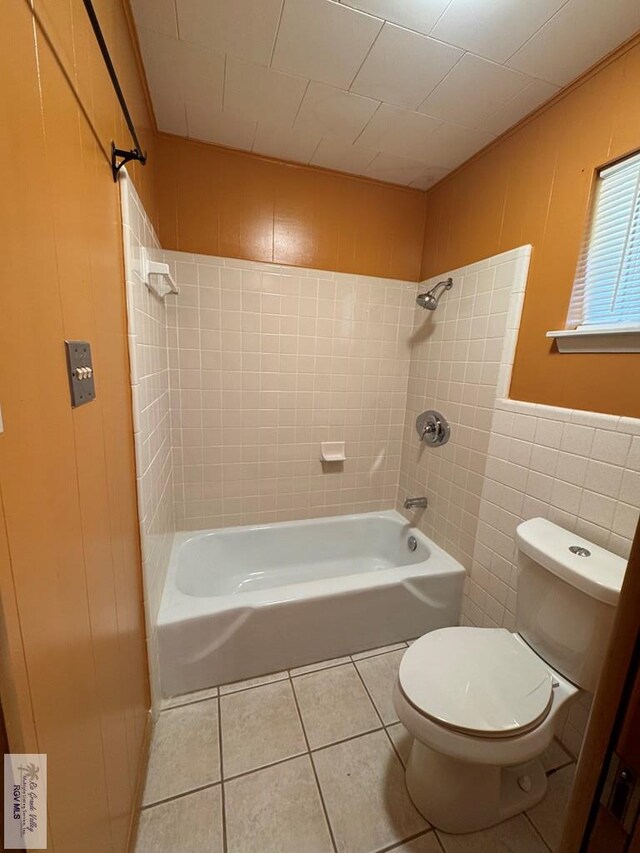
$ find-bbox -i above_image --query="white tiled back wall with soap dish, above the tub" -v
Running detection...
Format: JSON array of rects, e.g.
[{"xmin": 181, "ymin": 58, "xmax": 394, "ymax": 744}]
[{"xmin": 164, "ymin": 252, "xmax": 416, "ymax": 529}]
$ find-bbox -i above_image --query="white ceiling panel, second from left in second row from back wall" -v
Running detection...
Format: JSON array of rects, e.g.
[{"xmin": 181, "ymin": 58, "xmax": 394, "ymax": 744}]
[{"xmin": 224, "ymin": 56, "xmax": 308, "ymax": 127}]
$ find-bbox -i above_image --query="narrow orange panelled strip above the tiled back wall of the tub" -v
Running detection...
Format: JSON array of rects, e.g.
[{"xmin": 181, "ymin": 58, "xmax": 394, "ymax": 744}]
[{"xmin": 156, "ymin": 134, "xmax": 425, "ymax": 281}]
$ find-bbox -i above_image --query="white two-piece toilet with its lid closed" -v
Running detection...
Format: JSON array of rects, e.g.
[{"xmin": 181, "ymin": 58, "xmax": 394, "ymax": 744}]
[{"xmin": 393, "ymin": 518, "xmax": 626, "ymax": 833}]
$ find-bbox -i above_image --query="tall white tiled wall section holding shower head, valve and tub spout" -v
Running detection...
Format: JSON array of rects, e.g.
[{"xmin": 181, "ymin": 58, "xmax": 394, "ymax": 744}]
[{"xmin": 397, "ymin": 246, "xmax": 531, "ymax": 571}]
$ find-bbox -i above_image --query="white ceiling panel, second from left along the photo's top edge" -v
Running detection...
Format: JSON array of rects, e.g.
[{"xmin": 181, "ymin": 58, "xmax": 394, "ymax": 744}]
[{"xmin": 176, "ymin": 0, "xmax": 283, "ymax": 65}]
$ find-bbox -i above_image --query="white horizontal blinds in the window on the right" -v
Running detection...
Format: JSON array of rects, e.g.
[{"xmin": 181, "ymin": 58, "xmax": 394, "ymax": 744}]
[{"xmin": 567, "ymin": 154, "xmax": 640, "ymax": 332}]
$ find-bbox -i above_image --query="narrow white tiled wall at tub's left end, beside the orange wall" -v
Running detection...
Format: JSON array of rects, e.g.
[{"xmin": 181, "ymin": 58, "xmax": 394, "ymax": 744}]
[{"xmin": 120, "ymin": 170, "xmax": 175, "ymax": 713}]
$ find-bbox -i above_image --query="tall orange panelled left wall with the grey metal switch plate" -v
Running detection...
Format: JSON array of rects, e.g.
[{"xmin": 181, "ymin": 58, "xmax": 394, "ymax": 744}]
[{"xmin": 0, "ymin": 0, "xmax": 155, "ymax": 853}]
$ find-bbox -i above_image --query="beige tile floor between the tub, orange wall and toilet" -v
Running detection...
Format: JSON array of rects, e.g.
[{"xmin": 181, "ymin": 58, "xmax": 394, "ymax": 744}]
[{"xmin": 136, "ymin": 643, "xmax": 574, "ymax": 853}]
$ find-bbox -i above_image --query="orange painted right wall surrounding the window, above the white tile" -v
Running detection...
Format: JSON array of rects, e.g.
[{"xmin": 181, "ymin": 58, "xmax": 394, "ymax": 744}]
[{"xmin": 422, "ymin": 37, "xmax": 640, "ymax": 417}]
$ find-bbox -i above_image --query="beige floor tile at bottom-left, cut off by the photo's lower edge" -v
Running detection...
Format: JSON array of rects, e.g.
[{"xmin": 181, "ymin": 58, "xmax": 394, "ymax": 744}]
[{"xmin": 135, "ymin": 785, "xmax": 223, "ymax": 853}]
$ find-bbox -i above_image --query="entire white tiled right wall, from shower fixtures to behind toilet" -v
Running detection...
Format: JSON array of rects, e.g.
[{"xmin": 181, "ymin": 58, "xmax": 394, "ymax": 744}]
[{"xmin": 398, "ymin": 241, "xmax": 640, "ymax": 755}]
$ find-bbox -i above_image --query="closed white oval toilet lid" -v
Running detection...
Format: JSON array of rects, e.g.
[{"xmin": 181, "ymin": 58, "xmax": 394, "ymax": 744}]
[{"xmin": 399, "ymin": 627, "xmax": 552, "ymax": 737}]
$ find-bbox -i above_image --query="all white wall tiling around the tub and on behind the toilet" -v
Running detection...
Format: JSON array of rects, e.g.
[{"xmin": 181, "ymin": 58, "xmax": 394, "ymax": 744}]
[{"xmin": 125, "ymin": 181, "xmax": 640, "ymax": 753}]
